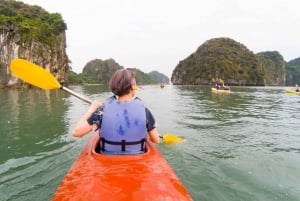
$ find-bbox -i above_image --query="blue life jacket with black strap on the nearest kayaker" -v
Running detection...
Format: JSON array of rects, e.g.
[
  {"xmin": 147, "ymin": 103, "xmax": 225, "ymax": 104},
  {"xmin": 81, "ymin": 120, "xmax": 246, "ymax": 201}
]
[{"xmin": 100, "ymin": 96, "xmax": 147, "ymax": 154}]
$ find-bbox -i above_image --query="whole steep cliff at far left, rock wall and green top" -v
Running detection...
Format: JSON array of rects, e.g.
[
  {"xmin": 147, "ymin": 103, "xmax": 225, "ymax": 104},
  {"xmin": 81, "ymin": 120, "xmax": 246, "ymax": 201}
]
[{"xmin": 0, "ymin": 1, "xmax": 70, "ymax": 88}]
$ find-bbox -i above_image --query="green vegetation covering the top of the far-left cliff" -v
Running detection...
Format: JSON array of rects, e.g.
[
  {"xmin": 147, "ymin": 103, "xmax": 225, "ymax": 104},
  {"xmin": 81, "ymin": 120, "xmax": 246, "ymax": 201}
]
[{"xmin": 0, "ymin": 0, "xmax": 67, "ymax": 46}]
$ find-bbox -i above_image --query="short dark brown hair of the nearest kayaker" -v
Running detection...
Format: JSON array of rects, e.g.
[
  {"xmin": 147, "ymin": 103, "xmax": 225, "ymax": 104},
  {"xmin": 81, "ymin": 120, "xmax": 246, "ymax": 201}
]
[{"xmin": 109, "ymin": 69, "xmax": 135, "ymax": 96}]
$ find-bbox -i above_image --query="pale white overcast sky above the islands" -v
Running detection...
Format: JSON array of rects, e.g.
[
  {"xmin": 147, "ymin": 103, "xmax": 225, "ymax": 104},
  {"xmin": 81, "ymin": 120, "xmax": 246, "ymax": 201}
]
[{"xmin": 19, "ymin": 0, "xmax": 300, "ymax": 77}]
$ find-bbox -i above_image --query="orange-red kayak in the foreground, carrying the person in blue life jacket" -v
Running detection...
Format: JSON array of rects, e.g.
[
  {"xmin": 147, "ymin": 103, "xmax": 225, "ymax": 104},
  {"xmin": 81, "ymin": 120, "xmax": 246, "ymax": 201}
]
[{"xmin": 52, "ymin": 134, "xmax": 193, "ymax": 201}]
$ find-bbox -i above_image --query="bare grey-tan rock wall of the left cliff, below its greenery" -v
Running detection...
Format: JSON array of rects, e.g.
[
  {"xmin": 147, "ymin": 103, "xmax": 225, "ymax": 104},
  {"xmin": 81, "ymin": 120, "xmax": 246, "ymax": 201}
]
[{"xmin": 0, "ymin": 27, "xmax": 70, "ymax": 88}]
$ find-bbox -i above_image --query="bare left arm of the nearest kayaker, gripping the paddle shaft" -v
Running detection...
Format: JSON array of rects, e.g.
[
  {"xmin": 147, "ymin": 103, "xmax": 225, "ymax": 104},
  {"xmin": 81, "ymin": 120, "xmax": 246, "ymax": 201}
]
[{"xmin": 72, "ymin": 101, "xmax": 101, "ymax": 137}]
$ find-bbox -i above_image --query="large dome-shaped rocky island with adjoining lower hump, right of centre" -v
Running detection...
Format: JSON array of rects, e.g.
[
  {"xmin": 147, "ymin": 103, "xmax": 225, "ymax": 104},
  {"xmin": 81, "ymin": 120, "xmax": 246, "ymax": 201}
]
[{"xmin": 171, "ymin": 38, "xmax": 286, "ymax": 86}]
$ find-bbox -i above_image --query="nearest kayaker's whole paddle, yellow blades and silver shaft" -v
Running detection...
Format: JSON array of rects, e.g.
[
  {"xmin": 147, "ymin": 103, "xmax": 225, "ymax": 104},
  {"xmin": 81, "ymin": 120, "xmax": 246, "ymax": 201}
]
[{"xmin": 10, "ymin": 59, "xmax": 183, "ymax": 144}]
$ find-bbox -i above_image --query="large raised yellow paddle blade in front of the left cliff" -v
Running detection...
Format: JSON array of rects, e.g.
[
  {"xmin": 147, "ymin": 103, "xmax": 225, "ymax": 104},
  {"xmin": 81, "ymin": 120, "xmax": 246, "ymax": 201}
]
[{"xmin": 10, "ymin": 59, "xmax": 61, "ymax": 89}]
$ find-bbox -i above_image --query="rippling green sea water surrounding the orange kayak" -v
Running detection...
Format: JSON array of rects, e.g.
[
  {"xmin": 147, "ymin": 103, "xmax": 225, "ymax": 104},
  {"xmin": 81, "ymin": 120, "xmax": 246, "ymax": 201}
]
[{"xmin": 0, "ymin": 86, "xmax": 300, "ymax": 201}]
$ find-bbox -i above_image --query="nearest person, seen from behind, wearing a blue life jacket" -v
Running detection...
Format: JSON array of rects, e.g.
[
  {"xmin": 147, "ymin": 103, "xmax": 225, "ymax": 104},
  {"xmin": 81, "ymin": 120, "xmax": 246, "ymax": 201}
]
[{"xmin": 72, "ymin": 69, "xmax": 159, "ymax": 154}]
